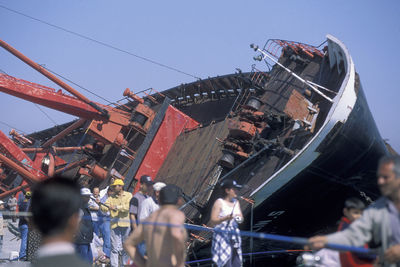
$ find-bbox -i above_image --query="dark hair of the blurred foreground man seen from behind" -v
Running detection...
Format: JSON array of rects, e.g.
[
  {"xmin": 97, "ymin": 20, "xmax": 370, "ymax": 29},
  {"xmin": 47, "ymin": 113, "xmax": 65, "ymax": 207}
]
[{"xmin": 31, "ymin": 177, "xmax": 81, "ymax": 236}]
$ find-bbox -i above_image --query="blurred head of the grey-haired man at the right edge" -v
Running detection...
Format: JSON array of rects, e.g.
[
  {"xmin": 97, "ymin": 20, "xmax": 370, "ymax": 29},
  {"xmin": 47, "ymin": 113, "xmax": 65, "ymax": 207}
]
[{"xmin": 377, "ymin": 156, "xmax": 400, "ymax": 199}]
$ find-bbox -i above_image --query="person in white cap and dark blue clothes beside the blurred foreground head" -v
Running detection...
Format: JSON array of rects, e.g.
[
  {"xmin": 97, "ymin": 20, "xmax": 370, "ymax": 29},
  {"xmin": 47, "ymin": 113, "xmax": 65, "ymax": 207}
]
[{"xmin": 75, "ymin": 187, "xmax": 93, "ymax": 264}]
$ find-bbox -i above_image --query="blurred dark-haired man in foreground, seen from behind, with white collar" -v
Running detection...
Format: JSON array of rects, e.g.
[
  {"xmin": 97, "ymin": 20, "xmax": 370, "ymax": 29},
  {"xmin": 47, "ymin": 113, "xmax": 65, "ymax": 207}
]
[{"xmin": 31, "ymin": 177, "xmax": 90, "ymax": 267}]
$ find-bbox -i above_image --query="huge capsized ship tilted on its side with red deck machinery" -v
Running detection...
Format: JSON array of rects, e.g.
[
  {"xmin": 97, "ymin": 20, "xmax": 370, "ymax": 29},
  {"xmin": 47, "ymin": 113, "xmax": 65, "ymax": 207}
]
[{"xmin": 0, "ymin": 35, "xmax": 389, "ymax": 264}]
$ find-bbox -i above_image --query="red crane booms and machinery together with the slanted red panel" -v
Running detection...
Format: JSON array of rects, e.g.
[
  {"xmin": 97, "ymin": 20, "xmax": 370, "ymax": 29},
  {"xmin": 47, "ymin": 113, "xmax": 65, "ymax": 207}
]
[{"xmin": 0, "ymin": 40, "xmax": 199, "ymax": 198}]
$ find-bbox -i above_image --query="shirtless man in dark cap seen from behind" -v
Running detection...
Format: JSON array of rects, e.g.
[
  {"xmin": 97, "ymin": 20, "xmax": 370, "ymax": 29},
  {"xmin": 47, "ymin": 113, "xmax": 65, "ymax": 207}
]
[{"xmin": 124, "ymin": 185, "xmax": 187, "ymax": 267}]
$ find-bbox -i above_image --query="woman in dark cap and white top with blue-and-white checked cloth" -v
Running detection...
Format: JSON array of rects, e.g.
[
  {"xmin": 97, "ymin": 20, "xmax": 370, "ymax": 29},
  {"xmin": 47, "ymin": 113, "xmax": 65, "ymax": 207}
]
[{"xmin": 210, "ymin": 179, "xmax": 243, "ymax": 267}]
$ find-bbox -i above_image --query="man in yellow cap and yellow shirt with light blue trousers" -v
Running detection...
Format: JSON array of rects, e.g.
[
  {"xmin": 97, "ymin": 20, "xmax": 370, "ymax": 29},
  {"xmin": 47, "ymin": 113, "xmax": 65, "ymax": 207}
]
[{"xmin": 101, "ymin": 179, "xmax": 132, "ymax": 267}]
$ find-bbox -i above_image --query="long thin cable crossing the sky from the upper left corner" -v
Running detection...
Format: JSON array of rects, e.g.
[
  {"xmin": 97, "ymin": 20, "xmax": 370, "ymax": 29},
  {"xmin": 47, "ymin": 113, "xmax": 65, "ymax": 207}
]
[{"xmin": 0, "ymin": 5, "xmax": 200, "ymax": 80}]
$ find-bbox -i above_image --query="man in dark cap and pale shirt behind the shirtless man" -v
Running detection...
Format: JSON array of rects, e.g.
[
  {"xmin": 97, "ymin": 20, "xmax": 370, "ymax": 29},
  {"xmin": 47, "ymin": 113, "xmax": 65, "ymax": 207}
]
[{"xmin": 129, "ymin": 175, "xmax": 153, "ymax": 231}]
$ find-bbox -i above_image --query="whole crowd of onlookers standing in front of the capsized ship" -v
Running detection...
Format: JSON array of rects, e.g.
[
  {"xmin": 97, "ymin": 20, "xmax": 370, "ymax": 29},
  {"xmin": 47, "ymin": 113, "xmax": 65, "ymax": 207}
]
[{"xmin": 0, "ymin": 156, "xmax": 400, "ymax": 267}]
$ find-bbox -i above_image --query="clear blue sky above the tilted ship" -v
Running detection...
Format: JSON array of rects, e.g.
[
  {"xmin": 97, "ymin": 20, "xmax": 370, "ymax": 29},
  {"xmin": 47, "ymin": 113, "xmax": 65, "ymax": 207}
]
[{"xmin": 0, "ymin": 0, "xmax": 400, "ymax": 151}]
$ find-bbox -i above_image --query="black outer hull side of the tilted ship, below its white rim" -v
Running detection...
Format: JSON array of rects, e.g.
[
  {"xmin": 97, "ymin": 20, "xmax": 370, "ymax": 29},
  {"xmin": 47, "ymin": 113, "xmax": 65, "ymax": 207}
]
[{"xmin": 244, "ymin": 80, "xmax": 388, "ymax": 254}]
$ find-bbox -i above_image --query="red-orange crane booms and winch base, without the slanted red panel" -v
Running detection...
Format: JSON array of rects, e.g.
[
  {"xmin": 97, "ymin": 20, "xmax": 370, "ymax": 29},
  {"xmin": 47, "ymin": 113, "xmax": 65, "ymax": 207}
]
[{"xmin": 0, "ymin": 40, "xmax": 158, "ymax": 197}]
